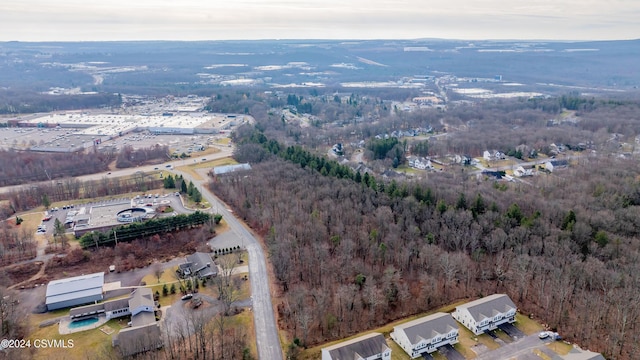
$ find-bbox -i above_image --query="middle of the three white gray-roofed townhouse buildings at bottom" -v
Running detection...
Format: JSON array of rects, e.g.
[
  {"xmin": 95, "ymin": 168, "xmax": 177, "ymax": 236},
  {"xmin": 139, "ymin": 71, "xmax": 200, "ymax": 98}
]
[{"xmin": 391, "ymin": 312, "xmax": 458, "ymax": 359}]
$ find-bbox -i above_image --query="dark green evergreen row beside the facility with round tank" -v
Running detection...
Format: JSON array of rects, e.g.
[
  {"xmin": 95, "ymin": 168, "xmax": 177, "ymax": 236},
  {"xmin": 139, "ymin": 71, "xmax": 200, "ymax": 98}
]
[{"xmin": 78, "ymin": 211, "xmax": 211, "ymax": 249}]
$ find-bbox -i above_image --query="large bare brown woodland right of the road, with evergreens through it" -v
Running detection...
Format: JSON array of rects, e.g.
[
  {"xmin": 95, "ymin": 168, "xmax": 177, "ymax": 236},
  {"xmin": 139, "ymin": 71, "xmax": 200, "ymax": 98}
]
[{"xmin": 211, "ymin": 122, "xmax": 640, "ymax": 358}]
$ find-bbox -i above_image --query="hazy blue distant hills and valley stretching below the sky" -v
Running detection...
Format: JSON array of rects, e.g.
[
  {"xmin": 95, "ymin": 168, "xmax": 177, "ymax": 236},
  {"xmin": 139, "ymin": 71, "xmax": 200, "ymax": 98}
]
[{"xmin": 0, "ymin": 39, "xmax": 640, "ymax": 93}]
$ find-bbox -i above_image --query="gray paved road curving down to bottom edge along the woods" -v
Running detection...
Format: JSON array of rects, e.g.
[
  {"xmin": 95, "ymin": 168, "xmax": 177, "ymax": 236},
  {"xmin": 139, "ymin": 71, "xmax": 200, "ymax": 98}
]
[{"xmin": 174, "ymin": 168, "xmax": 283, "ymax": 360}]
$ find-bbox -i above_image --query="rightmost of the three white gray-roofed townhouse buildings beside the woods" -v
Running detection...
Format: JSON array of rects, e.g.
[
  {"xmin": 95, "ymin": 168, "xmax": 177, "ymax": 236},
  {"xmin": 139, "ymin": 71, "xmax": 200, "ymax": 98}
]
[{"xmin": 451, "ymin": 294, "xmax": 517, "ymax": 335}]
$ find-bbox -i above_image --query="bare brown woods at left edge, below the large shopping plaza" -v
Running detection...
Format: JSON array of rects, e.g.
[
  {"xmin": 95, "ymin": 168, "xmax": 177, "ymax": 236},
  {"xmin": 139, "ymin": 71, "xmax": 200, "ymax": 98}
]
[{"xmin": 0, "ymin": 150, "xmax": 114, "ymax": 186}]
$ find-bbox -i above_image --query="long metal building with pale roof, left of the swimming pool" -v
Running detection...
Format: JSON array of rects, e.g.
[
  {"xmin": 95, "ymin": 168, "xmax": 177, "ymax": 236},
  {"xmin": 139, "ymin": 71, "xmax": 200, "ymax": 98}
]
[{"xmin": 45, "ymin": 272, "xmax": 104, "ymax": 311}]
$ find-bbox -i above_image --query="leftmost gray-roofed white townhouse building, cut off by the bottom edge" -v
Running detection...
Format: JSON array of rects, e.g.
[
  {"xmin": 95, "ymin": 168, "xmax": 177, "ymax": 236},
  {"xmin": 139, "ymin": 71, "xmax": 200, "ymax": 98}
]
[{"xmin": 321, "ymin": 333, "xmax": 391, "ymax": 360}]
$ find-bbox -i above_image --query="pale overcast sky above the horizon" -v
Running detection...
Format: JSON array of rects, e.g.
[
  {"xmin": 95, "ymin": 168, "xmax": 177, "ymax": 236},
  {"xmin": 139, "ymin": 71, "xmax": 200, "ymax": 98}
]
[{"xmin": 0, "ymin": 0, "xmax": 640, "ymax": 41}]
